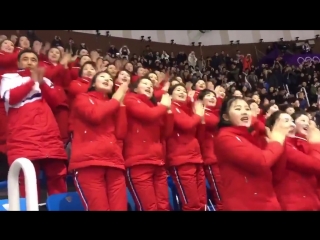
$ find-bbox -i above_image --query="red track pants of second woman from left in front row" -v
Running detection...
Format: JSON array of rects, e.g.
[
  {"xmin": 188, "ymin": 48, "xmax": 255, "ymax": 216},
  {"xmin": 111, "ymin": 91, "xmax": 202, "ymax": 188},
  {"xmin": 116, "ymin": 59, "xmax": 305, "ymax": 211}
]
[{"xmin": 126, "ymin": 165, "xmax": 170, "ymax": 211}]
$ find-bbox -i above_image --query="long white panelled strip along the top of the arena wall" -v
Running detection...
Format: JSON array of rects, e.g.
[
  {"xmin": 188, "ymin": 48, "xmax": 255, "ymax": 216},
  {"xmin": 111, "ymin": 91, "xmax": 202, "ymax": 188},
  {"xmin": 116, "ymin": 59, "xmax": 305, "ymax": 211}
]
[{"xmin": 73, "ymin": 30, "xmax": 320, "ymax": 46}]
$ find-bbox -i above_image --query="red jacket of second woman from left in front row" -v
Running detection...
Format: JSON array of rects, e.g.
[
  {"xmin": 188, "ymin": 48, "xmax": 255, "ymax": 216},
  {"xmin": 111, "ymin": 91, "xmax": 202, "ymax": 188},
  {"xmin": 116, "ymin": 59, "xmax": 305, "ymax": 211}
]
[{"xmin": 123, "ymin": 93, "xmax": 173, "ymax": 167}]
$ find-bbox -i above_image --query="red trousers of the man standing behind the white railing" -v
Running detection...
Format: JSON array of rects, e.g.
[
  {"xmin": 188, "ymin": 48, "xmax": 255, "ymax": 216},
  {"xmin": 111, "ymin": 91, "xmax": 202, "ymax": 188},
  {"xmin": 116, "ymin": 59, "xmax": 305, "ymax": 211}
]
[{"xmin": 19, "ymin": 159, "xmax": 68, "ymax": 200}]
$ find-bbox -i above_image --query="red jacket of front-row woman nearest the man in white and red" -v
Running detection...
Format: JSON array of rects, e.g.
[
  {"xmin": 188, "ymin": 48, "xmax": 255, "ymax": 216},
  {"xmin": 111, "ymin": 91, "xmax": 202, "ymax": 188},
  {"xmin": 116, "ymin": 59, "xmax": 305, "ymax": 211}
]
[{"xmin": 69, "ymin": 91, "xmax": 127, "ymax": 170}]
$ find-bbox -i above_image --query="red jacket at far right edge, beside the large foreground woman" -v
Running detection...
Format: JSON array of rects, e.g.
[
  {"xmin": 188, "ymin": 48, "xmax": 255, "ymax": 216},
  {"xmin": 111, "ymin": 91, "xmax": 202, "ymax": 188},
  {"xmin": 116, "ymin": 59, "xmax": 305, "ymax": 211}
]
[{"xmin": 275, "ymin": 137, "xmax": 320, "ymax": 211}]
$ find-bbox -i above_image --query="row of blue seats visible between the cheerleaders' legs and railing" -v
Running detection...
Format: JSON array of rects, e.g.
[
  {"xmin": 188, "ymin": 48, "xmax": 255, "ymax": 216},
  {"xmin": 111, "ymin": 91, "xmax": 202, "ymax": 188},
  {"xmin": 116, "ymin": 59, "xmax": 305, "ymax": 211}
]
[{"xmin": 0, "ymin": 172, "xmax": 215, "ymax": 211}]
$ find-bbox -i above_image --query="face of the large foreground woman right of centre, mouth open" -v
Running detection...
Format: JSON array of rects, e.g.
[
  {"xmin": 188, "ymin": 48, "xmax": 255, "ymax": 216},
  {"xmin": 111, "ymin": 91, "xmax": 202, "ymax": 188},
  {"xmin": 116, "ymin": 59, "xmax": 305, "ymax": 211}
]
[{"xmin": 223, "ymin": 99, "xmax": 252, "ymax": 127}]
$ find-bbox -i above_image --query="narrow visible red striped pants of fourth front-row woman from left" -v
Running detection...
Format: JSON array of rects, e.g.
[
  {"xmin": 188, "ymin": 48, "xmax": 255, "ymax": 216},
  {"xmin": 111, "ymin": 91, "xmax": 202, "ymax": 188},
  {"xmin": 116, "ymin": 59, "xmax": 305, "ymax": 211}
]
[{"xmin": 204, "ymin": 164, "xmax": 223, "ymax": 211}]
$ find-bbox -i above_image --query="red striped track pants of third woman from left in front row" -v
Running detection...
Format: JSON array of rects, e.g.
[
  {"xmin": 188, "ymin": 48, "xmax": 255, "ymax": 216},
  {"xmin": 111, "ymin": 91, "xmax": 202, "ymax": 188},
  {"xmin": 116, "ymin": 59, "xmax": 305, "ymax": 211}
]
[{"xmin": 169, "ymin": 163, "xmax": 207, "ymax": 211}]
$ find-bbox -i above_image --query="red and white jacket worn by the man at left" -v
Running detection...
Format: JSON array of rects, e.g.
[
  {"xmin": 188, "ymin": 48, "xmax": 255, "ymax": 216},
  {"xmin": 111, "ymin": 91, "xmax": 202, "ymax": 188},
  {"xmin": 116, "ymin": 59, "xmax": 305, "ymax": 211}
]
[{"xmin": 1, "ymin": 70, "xmax": 67, "ymax": 164}]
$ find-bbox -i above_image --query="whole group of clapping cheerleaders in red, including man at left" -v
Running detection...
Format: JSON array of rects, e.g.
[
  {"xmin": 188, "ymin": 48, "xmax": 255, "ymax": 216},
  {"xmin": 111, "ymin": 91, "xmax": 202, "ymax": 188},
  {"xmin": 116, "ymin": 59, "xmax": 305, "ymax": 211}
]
[{"xmin": 0, "ymin": 34, "xmax": 320, "ymax": 211}]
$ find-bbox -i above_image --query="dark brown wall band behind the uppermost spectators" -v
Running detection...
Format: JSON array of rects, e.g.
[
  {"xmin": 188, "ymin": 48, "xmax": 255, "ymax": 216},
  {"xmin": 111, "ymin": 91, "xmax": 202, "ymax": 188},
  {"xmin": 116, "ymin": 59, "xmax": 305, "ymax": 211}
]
[{"xmin": 0, "ymin": 30, "xmax": 320, "ymax": 61}]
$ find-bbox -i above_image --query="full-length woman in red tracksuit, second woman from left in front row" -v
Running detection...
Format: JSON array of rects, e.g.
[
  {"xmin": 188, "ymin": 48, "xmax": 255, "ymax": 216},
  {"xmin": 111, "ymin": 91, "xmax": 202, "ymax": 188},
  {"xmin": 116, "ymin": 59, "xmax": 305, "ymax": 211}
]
[{"xmin": 123, "ymin": 77, "xmax": 173, "ymax": 211}]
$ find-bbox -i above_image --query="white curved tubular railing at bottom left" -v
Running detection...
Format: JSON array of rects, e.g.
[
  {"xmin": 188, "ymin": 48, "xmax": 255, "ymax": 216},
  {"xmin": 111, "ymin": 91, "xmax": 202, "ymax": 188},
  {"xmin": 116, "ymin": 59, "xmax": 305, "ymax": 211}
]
[{"xmin": 8, "ymin": 158, "xmax": 39, "ymax": 211}]
